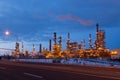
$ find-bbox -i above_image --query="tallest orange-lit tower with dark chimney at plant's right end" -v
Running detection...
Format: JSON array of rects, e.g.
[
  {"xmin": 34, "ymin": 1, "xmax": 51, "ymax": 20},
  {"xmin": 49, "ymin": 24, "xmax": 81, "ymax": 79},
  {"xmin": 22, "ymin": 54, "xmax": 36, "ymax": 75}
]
[{"xmin": 95, "ymin": 24, "xmax": 110, "ymax": 58}]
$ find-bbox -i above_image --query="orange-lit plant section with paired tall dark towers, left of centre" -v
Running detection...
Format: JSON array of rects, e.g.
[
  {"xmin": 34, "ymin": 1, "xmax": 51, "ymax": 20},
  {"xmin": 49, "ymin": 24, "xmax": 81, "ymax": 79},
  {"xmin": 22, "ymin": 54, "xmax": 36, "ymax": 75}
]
[{"xmin": 41, "ymin": 32, "xmax": 62, "ymax": 58}]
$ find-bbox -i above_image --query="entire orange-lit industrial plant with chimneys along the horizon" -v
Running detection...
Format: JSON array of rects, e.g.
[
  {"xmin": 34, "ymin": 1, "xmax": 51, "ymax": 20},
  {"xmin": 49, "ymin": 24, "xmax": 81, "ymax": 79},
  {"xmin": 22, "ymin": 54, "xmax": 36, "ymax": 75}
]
[{"xmin": 12, "ymin": 23, "xmax": 116, "ymax": 58}]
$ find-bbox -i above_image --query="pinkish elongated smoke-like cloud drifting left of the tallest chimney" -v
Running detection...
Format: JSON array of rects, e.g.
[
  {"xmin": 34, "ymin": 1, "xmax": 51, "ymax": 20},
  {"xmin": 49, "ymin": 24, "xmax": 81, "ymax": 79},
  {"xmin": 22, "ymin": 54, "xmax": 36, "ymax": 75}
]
[{"xmin": 58, "ymin": 15, "xmax": 94, "ymax": 26}]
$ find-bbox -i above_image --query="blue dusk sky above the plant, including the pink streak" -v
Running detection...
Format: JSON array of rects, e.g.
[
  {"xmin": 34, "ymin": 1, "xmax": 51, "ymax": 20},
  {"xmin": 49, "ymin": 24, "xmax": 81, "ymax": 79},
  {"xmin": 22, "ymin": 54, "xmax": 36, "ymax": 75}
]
[{"xmin": 0, "ymin": 0, "xmax": 120, "ymax": 53}]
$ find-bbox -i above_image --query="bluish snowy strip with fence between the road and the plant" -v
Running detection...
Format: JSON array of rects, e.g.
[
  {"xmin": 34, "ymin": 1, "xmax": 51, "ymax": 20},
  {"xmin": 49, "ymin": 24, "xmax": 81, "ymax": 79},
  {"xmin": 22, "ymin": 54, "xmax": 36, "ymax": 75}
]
[{"xmin": 11, "ymin": 58, "xmax": 120, "ymax": 67}]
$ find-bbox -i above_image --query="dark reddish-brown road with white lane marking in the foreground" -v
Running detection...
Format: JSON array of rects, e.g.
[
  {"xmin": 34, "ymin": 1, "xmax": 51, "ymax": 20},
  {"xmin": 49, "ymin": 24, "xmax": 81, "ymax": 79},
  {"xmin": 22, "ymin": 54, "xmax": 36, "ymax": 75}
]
[{"xmin": 0, "ymin": 61, "xmax": 120, "ymax": 80}]
